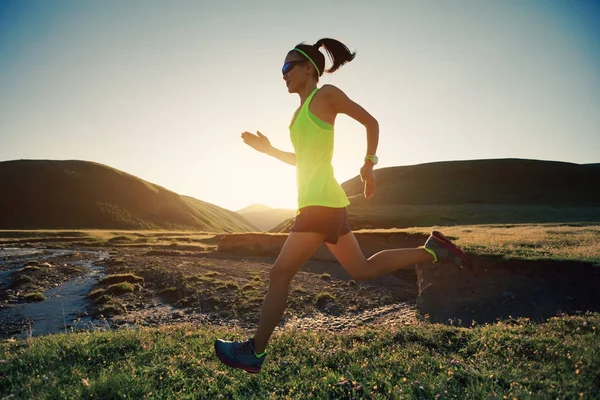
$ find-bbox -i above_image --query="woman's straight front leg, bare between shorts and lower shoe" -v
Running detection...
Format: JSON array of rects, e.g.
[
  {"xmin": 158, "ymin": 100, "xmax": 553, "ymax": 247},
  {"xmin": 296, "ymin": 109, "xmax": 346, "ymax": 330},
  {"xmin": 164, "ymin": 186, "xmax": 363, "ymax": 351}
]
[{"xmin": 252, "ymin": 232, "xmax": 325, "ymax": 354}]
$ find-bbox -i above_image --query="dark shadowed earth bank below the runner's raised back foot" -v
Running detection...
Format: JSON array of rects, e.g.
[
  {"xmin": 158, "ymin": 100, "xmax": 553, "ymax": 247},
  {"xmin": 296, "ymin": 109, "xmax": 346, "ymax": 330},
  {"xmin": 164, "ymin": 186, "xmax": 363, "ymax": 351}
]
[{"xmin": 417, "ymin": 257, "xmax": 600, "ymax": 325}]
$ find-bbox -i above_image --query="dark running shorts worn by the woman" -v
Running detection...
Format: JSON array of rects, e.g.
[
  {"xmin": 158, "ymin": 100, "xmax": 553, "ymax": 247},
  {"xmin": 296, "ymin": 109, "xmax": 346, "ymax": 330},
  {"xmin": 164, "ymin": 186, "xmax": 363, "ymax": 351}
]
[{"xmin": 290, "ymin": 206, "xmax": 350, "ymax": 244}]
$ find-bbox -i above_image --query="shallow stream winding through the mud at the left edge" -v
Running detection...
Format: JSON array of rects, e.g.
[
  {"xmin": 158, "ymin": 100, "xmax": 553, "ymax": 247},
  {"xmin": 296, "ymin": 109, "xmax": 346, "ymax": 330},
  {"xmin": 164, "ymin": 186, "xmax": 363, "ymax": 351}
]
[{"xmin": 0, "ymin": 248, "xmax": 108, "ymax": 339}]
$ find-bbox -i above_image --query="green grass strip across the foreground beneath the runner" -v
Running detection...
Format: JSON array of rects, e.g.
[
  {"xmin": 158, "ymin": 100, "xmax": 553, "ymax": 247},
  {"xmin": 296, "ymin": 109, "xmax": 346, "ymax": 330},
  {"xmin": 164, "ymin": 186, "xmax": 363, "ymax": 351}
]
[{"xmin": 0, "ymin": 314, "xmax": 600, "ymax": 399}]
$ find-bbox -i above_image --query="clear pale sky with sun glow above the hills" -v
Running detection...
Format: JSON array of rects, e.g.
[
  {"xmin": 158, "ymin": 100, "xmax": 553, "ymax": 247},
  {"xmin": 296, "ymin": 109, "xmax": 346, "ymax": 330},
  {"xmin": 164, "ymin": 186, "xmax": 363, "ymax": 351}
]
[{"xmin": 0, "ymin": 0, "xmax": 600, "ymax": 211}]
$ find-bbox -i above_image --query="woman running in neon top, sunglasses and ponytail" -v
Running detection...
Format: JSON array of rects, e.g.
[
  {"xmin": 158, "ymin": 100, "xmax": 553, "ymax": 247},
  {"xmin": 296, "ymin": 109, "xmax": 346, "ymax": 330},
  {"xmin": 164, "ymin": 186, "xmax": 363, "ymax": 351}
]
[{"xmin": 215, "ymin": 38, "xmax": 470, "ymax": 373}]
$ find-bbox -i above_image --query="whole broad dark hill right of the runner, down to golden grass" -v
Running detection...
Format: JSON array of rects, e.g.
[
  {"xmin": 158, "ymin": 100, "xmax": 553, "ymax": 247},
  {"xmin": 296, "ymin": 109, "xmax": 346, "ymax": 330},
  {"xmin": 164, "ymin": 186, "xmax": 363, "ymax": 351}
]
[{"xmin": 272, "ymin": 159, "xmax": 600, "ymax": 232}]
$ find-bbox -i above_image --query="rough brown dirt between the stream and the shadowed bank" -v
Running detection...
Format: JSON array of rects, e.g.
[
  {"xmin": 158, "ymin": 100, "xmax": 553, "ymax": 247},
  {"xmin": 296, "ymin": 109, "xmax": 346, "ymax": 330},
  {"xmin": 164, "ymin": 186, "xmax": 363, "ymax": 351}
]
[{"xmin": 92, "ymin": 249, "xmax": 417, "ymax": 326}]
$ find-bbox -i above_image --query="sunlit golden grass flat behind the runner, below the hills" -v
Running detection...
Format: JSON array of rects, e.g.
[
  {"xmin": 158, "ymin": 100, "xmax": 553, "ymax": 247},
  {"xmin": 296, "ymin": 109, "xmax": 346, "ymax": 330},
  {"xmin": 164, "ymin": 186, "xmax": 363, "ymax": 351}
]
[{"xmin": 0, "ymin": 223, "xmax": 600, "ymax": 264}]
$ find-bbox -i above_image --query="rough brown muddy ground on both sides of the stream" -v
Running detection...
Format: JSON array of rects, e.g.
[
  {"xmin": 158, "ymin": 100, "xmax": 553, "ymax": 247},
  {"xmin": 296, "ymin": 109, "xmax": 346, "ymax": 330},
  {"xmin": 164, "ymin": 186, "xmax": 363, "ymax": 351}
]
[{"xmin": 0, "ymin": 243, "xmax": 418, "ymax": 338}]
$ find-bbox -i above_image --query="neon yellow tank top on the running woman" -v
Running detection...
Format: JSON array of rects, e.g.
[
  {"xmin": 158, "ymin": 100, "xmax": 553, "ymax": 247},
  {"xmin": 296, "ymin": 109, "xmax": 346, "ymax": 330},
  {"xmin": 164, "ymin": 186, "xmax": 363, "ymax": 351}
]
[{"xmin": 290, "ymin": 88, "xmax": 350, "ymax": 209}]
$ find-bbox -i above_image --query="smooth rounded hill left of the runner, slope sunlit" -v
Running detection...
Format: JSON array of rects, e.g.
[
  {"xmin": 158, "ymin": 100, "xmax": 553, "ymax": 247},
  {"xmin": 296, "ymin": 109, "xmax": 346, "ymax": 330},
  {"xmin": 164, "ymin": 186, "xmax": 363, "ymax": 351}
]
[{"xmin": 0, "ymin": 160, "xmax": 260, "ymax": 232}]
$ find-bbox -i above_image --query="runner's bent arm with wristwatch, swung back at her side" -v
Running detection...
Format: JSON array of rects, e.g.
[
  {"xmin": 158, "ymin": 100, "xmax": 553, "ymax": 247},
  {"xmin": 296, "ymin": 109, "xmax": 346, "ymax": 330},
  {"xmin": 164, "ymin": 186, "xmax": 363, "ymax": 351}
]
[{"xmin": 321, "ymin": 85, "xmax": 379, "ymax": 199}]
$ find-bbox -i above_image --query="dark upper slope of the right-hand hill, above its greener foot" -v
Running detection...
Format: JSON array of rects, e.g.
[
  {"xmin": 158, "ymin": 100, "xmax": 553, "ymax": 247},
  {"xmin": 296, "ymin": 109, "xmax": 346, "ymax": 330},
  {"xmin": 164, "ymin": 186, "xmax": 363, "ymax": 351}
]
[{"xmin": 342, "ymin": 159, "xmax": 600, "ymax": 206}]
